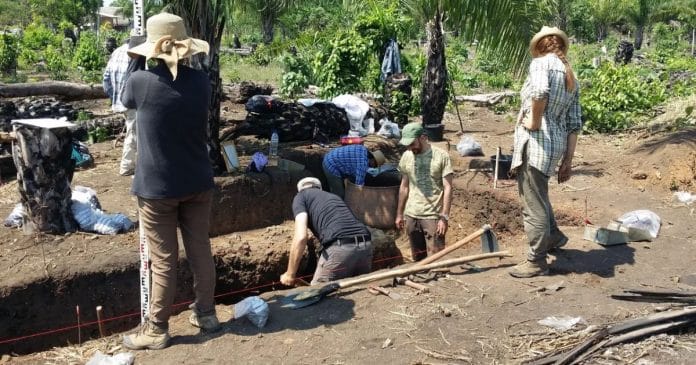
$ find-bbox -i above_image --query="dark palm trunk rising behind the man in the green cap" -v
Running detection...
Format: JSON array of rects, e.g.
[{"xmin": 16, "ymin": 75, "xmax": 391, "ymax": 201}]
[{"xmin": 421, "ymin": 11, "xmax": 447, "ymax": 125}]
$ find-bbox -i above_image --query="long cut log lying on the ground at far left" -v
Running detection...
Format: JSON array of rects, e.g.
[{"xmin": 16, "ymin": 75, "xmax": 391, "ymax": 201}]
[{"xmin": 0, "ymin": 81, "xmax": 107, "ymax": 100}]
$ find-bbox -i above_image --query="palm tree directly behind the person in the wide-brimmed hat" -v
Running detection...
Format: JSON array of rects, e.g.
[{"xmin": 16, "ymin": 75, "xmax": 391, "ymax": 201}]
[{"xmin": 162, "ymin": 0, "xmax": 231, "ymax": 174}]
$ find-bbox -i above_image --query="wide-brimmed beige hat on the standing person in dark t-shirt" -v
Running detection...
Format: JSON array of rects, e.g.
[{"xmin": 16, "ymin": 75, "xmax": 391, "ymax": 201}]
[{"xmin": 128, "ymin": 13, "xmax": 210, "ymax": 80}]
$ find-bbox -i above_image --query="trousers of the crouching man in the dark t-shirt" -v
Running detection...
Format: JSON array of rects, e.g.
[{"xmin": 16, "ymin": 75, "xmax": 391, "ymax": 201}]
[{"xmin": 311, "ymin": 241, "xmax": 372, "ymax": 285}]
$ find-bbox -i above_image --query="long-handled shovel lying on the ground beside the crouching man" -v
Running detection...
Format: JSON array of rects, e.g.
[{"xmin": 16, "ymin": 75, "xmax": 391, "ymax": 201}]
[{"xmin": 280, "ymin": 251, "xmax": 511, "ymax": 309}]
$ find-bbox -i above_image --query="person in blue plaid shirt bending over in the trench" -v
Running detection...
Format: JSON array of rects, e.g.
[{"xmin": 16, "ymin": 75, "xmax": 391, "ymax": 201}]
[{"xmin": 322, "ymin": 144, "xmax": 386, "ymax": 199}]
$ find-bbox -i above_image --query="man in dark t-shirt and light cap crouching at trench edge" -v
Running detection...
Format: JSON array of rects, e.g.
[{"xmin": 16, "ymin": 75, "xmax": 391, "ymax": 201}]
[{"xmin": 280, "ymin": 177, "xmax": 372, "ymax": 286}]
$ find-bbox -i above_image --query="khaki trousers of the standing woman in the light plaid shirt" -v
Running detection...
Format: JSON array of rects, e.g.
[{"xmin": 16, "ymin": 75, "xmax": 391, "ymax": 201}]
[{"xmin": 517, "ymin": 148, "xmax": 566, "ymax": 261}]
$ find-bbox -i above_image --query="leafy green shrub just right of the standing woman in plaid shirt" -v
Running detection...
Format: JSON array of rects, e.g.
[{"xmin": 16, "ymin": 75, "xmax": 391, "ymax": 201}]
[{"xmin": 580, "ymin": 62, "xmax": 666, "ymax": 132}]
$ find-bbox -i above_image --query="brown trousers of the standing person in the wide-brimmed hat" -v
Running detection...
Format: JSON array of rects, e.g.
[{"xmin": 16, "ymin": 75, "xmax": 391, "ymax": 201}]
[{"xmin": 138, "ymin": 190, "xmax": 215, "ymax": 323}]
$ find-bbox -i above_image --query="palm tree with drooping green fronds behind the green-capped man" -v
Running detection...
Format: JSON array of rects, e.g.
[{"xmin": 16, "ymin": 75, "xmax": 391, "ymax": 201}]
[{"xmin": 402, "ymin": 0, "xmax": 553, "ymax": 124}]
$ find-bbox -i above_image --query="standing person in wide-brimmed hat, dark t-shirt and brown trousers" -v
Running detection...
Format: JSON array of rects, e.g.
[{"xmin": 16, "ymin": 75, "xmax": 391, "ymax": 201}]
[{"xmin": 121, "ymin": 13, "xmax": 220, "ymax": 350}]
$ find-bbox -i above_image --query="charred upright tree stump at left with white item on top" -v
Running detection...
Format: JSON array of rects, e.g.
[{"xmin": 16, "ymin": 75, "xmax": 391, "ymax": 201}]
[{"xmin": 12, "ymin": 124, "xmax": 77, "ymax": 230}]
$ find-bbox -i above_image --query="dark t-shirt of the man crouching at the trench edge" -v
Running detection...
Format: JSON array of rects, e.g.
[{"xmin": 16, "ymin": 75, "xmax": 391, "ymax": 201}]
[{"xmin": 292, "ymin": 188, "xmax": 370, "ymax": 245}]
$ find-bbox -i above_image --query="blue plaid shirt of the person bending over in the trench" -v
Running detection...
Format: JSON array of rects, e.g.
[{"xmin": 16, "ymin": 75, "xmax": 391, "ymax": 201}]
[{"xmin": 324, "ymin": 144, "xmax": 369, "ymax": 186}]
